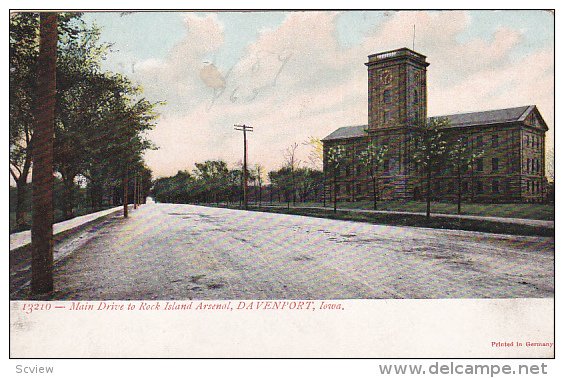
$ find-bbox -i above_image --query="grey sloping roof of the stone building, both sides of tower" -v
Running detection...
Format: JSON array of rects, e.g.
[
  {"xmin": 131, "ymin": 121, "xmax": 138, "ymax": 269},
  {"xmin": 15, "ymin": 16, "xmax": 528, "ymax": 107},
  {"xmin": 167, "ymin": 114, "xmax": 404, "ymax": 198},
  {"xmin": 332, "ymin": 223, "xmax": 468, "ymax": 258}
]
[{"xmin": 322, "ymin": 105, "xmax": 536, "ymax": 141}]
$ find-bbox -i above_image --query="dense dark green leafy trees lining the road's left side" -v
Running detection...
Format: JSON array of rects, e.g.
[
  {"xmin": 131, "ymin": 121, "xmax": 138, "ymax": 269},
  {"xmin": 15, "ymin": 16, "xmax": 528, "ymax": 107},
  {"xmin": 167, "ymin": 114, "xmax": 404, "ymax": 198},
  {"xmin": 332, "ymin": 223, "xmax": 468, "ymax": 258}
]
[{"xmin": 9, "ymin": 12, "xmax": 158, "ymax": 229}]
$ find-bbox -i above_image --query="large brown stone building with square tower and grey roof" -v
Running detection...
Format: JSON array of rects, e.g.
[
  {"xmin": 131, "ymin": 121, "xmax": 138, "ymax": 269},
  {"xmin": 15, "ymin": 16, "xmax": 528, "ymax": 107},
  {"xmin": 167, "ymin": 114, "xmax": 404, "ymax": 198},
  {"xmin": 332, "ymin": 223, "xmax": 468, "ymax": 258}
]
[{"xmin": 323, "ymin": 48, "xmax": 548, "ymax": 202}]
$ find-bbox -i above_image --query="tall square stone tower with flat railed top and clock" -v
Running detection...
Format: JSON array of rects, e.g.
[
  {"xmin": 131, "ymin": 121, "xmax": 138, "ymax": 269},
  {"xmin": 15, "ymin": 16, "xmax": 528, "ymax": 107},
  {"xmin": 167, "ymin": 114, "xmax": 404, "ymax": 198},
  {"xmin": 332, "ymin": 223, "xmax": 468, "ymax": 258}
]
[{"xmin": 365, "ymin": 48, "xmax": 429, "ymax": 199}]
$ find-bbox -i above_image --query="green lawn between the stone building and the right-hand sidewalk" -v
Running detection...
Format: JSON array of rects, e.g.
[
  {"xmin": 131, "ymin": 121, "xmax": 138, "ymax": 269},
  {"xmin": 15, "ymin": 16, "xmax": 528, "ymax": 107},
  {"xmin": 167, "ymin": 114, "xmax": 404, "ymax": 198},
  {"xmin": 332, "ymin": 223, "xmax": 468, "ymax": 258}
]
[{"xmin": 265, "ymin": 201, "xmax": 554, "ymax": 220}]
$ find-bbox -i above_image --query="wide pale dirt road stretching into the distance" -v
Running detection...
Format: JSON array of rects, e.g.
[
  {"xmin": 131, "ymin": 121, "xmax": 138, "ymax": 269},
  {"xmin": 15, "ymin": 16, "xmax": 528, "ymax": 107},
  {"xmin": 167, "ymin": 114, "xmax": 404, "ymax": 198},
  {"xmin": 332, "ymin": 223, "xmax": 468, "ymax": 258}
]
[{"xmin": 9, "ymin": 204, "xmax": 554, "ymax": 300}]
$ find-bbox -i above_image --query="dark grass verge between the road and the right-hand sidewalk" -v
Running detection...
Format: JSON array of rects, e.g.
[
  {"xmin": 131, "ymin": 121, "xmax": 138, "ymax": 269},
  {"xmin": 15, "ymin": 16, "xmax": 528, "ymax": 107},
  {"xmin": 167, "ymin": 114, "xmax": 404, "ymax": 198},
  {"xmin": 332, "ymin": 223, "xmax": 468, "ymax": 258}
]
[{"xmin": 236, "ymin": 207, "xmax": 554, "ymax": 237}]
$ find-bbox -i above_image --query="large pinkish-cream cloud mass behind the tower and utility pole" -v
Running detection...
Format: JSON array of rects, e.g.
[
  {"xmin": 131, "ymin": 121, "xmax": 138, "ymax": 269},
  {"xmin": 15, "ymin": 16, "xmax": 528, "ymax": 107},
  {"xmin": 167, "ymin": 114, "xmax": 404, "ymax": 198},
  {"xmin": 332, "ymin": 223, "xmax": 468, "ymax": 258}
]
[{"xmin": 135, "ymin": 11, "xmax": 554, "ymax": 179}]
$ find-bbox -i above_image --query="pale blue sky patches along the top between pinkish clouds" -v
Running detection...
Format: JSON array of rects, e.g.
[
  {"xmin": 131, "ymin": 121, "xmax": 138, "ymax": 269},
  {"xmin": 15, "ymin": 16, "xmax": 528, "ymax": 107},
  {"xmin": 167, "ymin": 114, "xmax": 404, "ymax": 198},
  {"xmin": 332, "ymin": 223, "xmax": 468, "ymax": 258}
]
[{"xmin": 84, "ymin": 10, "xmax": 554, "ymax": 72}]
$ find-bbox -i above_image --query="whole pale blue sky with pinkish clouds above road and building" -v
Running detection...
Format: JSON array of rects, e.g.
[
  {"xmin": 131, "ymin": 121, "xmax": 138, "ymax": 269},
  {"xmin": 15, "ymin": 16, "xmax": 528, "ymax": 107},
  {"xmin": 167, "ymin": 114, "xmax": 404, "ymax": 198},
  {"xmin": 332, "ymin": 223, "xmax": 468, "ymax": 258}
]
[{"xmin": 84, "ymin": 11, "xmax": 554, "ymax": 177}]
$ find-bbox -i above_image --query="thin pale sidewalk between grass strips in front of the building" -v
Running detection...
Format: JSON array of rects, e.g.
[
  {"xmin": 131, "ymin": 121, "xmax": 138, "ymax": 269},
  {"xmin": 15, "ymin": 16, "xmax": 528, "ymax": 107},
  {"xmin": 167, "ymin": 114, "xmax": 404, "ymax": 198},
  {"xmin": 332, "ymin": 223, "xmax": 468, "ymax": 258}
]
[{"xmin": 253, "ymin": 205, "xmax": 554, "ymax": 229}]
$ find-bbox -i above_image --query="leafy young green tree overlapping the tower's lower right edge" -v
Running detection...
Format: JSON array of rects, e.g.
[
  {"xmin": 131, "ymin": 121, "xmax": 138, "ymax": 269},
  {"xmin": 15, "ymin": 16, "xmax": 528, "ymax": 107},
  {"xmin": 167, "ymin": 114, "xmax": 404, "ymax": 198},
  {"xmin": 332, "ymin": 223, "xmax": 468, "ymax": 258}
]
[{"xmin": 414, "ymin": 118, "xmax": 449, "ymax": 218}]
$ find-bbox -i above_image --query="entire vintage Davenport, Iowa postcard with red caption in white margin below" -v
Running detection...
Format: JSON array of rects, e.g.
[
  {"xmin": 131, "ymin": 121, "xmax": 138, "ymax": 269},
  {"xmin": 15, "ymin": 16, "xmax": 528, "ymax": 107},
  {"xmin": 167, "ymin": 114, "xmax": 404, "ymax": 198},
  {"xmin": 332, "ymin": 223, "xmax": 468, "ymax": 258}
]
[{"xmin": 9, "ymin": 10, "xmax": 555, "ymax": 358}]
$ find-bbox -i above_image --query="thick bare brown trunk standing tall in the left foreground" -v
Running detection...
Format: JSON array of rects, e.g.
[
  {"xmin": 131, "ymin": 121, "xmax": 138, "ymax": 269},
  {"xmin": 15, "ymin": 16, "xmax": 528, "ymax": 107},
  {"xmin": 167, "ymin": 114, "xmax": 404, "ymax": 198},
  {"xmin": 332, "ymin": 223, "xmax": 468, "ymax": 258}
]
[{"xmin": 31, "ymin": 12, "xmax": 57, "ymax": 294}]
